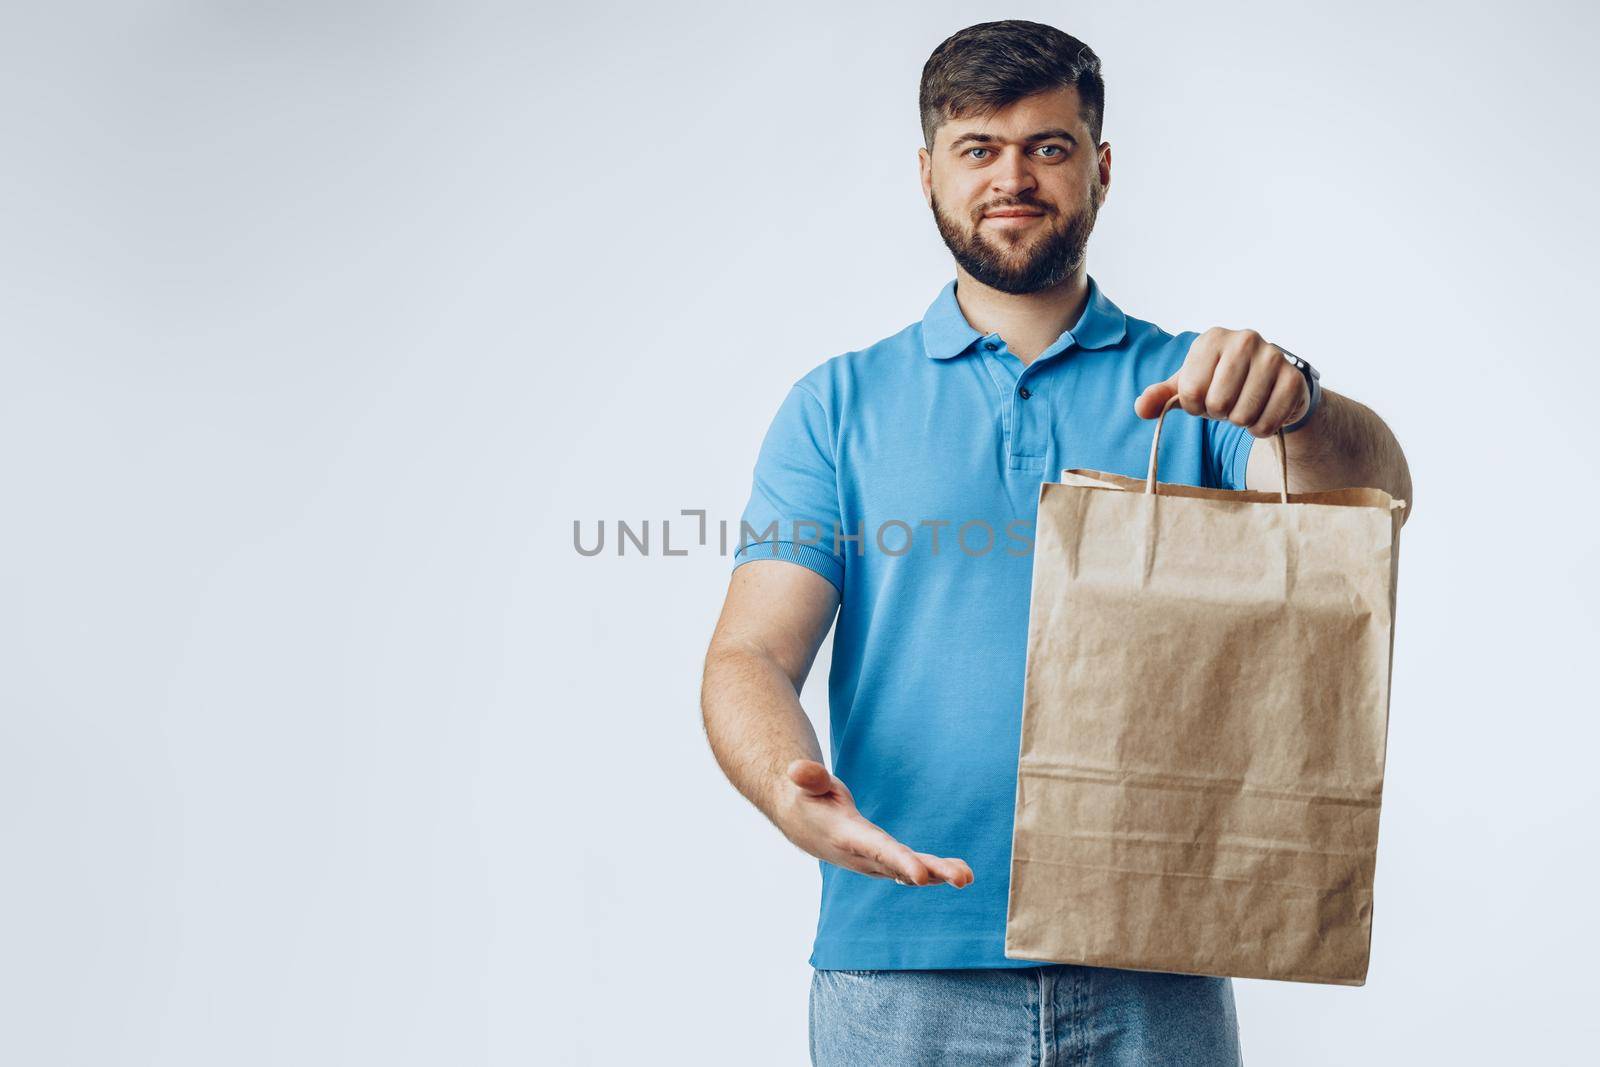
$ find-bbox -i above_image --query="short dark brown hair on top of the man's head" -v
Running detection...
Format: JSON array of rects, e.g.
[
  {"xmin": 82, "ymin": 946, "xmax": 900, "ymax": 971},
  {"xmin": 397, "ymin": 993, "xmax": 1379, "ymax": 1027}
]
[{"xmin": 917, "ymin": 19, "xmax": 1106, "ymax": 152}]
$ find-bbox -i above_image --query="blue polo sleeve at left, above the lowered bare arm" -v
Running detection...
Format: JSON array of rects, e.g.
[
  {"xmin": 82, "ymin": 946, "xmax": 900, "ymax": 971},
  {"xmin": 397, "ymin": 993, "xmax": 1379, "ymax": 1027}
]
[{"xmin": 733, "ymin": 384, "xmax": 845, "ymax": 595}]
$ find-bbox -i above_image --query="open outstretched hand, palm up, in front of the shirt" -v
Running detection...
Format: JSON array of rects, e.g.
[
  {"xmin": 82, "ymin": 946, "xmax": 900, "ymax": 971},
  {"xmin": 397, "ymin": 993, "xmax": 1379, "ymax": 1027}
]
[{"xmin": 779, "ymin": 760, "xmax": 973, "ymax": 889}]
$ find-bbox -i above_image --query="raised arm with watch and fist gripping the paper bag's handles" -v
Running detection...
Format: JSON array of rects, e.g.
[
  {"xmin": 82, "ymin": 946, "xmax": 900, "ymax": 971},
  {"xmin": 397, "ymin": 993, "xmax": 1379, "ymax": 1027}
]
[{"xmin": 1133, "ymin": 328, "xmax": 1416, "ymax": 523}]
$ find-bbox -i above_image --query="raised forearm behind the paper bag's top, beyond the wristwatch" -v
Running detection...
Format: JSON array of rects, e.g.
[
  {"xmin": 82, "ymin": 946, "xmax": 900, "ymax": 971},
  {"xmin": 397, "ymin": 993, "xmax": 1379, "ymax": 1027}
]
[{"xmin": 1258, "ymin": 389, "xmax": 1413, "ymax": 517}]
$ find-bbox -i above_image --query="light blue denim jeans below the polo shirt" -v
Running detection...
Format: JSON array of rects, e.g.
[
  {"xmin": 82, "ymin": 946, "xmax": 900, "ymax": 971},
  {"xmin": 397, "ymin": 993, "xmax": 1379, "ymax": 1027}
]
[{"xmin": 811, "ymin": 963, "xmax": 1243, "ymax": 1067}]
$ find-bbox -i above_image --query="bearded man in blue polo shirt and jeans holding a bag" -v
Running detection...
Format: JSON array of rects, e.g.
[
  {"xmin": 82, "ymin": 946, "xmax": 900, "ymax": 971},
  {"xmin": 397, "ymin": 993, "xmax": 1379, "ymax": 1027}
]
[{"xmin": 702, "ymin": 21, "xmax": 1414, "ymax": 1065}]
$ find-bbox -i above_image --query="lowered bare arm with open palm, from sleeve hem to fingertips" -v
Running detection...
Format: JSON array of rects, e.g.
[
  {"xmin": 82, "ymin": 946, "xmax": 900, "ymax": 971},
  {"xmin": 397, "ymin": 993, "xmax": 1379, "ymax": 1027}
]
[{"xmin": 701, "ymin": 560, "xmax": 973, "ymax": 888}]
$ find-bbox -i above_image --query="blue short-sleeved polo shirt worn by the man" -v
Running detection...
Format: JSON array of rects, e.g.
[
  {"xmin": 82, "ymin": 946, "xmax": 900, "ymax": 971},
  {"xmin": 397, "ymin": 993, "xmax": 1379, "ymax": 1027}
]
[{"xmin": 734, "ymin": 278, "xmax": 1254, "ymax": 969}]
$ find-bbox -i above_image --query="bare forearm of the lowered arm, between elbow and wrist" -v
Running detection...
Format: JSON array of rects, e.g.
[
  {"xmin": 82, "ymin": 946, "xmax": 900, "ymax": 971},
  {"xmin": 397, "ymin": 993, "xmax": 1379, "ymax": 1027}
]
[{"xmin": 701, "ymin": 646, "xmax": 824, "ymax": 830}]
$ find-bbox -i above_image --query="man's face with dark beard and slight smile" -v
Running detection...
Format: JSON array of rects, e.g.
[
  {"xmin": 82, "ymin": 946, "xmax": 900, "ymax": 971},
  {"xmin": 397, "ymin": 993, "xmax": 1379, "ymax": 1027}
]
[{"xmin": 917, "ymin": 88, "xmax": 1110, "ymax": 293}]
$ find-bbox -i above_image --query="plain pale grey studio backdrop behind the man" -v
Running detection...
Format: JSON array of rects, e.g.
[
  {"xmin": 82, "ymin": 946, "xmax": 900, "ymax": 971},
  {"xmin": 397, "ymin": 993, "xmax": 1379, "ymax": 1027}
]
[{"xmin": 0, "ymin": 2, "xmax": 1600, "ymax": 1065}]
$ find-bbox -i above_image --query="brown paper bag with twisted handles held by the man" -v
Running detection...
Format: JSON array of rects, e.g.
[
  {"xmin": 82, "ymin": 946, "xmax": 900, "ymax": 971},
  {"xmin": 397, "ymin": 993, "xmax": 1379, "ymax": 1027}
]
[{"xmin": 1005, "ymin": 402, "xmax": 1405, "ymax": 985}]
